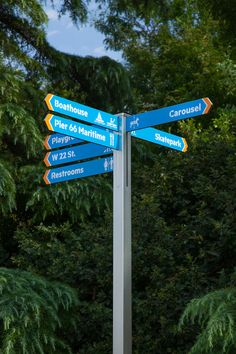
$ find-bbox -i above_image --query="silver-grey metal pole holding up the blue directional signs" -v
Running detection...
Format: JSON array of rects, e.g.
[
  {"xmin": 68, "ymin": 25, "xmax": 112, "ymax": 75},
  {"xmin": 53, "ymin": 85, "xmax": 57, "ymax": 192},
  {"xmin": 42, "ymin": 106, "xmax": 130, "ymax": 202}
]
[{"xmin": 113, "ymin": 113, "xmax": 132, "ymax": 354}]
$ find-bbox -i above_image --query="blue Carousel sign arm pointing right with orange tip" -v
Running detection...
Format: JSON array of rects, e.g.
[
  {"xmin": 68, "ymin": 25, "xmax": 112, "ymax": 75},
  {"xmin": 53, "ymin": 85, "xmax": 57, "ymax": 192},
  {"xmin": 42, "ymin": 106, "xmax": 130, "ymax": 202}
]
[{"xmin": 126, "ymin": 97, "xmax": 212, "ymax": 131}]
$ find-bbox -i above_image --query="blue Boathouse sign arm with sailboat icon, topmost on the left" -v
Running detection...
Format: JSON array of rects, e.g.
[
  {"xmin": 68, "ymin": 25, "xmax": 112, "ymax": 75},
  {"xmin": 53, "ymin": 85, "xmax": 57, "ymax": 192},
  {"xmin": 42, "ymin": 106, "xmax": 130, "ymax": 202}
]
[{"xmin": 45, "ymin": 93, "xmax": 119, "ymax": 131}]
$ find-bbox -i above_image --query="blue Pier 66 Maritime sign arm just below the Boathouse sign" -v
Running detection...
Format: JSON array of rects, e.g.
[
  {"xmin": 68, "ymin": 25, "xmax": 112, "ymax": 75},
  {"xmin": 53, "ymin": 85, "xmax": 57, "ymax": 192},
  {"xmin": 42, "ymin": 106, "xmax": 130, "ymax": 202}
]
[{"xmin": 45, "ymin": 114, "xmax": 119, "ymax": 150}]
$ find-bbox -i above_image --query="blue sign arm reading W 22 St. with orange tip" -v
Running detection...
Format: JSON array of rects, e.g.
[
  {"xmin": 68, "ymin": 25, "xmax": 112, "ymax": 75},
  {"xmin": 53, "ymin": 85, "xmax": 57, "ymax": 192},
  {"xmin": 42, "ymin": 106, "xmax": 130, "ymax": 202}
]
[{"xmin": 43, "ymin": 143, "xmax": 113, "ymax": 166}]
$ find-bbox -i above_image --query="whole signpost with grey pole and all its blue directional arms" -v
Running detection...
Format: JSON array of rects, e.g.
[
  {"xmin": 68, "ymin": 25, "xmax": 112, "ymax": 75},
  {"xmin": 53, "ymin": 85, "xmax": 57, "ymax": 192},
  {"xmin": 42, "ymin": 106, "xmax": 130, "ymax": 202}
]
[{"xmin": 43, "ymin": 94, "xmax": 212, "ymax": 354}]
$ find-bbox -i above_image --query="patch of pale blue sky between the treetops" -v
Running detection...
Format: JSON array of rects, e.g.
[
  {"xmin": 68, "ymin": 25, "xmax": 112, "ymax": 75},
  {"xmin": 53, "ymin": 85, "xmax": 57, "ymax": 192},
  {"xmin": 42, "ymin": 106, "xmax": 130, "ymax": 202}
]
[{"xmin": 45, "ymin": 4, "xmax": 122, "ymax": 62}]
